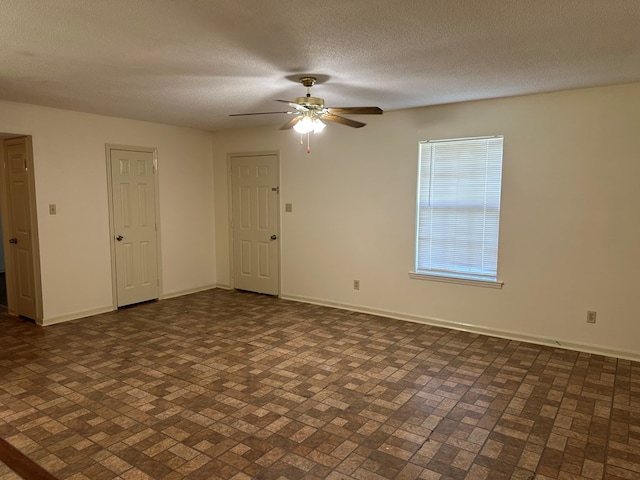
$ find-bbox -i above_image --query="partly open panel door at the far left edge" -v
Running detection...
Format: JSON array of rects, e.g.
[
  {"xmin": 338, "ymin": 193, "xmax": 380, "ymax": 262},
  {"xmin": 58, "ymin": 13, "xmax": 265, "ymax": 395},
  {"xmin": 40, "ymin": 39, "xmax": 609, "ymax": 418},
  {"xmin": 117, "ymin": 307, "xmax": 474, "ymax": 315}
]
[{"xmin": 4, "ymin": 137, "xmax": 36, "ymax": 320}]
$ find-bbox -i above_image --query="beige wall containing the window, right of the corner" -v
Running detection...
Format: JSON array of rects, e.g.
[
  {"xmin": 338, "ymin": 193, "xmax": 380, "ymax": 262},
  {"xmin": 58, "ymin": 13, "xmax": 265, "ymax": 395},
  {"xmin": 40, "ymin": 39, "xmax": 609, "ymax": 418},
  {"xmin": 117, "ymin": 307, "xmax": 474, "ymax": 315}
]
[{"xmin": 213, "ymin": 84, "xmax": 640, "ymax": 358}]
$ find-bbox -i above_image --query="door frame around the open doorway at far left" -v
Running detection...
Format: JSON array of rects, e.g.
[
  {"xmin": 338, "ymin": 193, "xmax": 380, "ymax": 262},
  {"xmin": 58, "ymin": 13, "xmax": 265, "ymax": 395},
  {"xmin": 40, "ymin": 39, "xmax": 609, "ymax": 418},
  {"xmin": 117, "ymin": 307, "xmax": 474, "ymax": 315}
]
[{"xmin": 0, "ymin": 134, "xmax": 44, "ymax": 325}]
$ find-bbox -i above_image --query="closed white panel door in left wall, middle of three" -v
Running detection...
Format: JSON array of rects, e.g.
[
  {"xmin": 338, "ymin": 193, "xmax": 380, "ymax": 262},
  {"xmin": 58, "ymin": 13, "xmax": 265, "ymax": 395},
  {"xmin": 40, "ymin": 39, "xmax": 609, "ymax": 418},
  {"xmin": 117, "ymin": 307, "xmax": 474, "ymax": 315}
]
[{"xmin": 110, "ymin": 149, "xmax": 159, "ymax": 307}]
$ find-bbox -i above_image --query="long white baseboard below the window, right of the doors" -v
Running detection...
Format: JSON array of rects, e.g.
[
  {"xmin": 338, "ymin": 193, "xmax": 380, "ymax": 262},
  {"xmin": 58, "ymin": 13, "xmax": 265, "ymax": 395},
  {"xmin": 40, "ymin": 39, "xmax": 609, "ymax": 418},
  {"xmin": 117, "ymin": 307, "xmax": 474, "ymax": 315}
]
[{"xmin": 280, "ymin": 293, "xmax": 640, "ymax": 362}]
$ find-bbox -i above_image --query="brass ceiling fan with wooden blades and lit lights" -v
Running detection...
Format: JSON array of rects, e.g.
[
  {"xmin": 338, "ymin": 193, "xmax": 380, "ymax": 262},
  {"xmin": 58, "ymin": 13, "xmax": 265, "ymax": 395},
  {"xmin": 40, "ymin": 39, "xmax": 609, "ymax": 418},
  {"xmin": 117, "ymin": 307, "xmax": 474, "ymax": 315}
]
[{"xmin": 229, "ymin": 77, "xmax": 382, "ymax": 151}]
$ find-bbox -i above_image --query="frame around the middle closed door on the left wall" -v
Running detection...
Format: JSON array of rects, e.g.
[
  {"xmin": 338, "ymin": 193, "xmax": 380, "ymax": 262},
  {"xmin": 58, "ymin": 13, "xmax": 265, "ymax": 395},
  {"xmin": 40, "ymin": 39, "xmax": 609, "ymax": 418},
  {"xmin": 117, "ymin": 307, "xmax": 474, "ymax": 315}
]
[{"xmin": 105, "ymin": 143, "xmax": 163, "ymax": 310}]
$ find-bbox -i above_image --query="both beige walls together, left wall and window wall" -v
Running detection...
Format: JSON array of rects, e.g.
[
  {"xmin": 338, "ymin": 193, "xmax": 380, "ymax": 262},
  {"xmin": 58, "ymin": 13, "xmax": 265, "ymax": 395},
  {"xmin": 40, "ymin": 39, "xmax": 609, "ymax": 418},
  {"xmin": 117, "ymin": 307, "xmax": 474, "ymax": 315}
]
[{"xmin": 6, "ymin": 84, "xmax": 640, "ymax": 358}]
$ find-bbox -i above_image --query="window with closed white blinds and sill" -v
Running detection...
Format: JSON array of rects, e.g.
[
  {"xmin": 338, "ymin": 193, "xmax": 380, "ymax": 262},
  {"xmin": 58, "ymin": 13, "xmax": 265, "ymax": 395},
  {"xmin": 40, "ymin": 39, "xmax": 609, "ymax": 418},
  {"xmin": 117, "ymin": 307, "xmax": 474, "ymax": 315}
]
[{"xmin": 411, "ymin": 136, "xmax": 503, "ymax": 288}]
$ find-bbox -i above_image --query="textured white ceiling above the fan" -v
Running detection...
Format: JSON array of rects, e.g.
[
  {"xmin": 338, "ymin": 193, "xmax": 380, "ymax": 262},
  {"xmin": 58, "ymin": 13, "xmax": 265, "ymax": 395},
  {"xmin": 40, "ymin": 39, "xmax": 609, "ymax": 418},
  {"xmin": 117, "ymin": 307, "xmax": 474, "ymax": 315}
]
[{"xmin": 0, "ymin": 0, "xmax": 640, "ymax": 130}]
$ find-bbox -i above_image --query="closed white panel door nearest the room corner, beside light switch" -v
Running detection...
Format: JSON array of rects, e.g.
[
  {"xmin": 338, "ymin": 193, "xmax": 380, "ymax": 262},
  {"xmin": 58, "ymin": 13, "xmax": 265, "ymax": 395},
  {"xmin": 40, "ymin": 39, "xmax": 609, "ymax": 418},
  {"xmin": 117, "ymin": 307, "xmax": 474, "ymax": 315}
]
[{"xmin": 231, "ymin": 155, "xmax": 280, "ymax": 295}]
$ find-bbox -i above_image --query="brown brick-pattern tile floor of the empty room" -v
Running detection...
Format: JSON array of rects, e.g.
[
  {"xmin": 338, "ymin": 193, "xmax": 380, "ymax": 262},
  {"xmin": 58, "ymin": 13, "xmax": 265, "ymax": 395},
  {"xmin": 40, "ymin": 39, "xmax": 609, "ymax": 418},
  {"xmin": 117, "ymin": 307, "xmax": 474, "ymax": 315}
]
[{"xmin": 0, "ymin": 290, "xmax": 640, "ymax": 480}]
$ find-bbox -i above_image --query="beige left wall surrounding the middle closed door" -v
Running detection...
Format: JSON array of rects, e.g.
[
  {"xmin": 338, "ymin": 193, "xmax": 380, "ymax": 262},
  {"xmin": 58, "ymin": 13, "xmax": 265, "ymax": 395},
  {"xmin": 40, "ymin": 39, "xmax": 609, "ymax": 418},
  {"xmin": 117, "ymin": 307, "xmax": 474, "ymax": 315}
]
[{"xmin": 0, "ymin": 102, "xmax": 215, "ymax": 323}]
